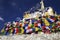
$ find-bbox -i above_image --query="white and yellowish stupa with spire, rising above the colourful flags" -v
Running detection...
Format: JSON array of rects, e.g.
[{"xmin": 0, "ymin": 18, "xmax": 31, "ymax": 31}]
[{"xmin": 23, "ymin": 0, "xmax": 54, "ymax": 21}]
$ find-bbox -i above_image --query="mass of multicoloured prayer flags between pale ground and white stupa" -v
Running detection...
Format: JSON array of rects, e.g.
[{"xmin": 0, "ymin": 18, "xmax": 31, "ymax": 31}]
[{"xmin": 1, "ymin": 16, "xmax": 60, "ymax": 35}]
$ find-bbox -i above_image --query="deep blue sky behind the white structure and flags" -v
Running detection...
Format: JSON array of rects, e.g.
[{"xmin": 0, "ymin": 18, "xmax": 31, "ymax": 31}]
[{"xmin": 0, "ymin": 0, "xmax": 60, "ymax": 29}]
